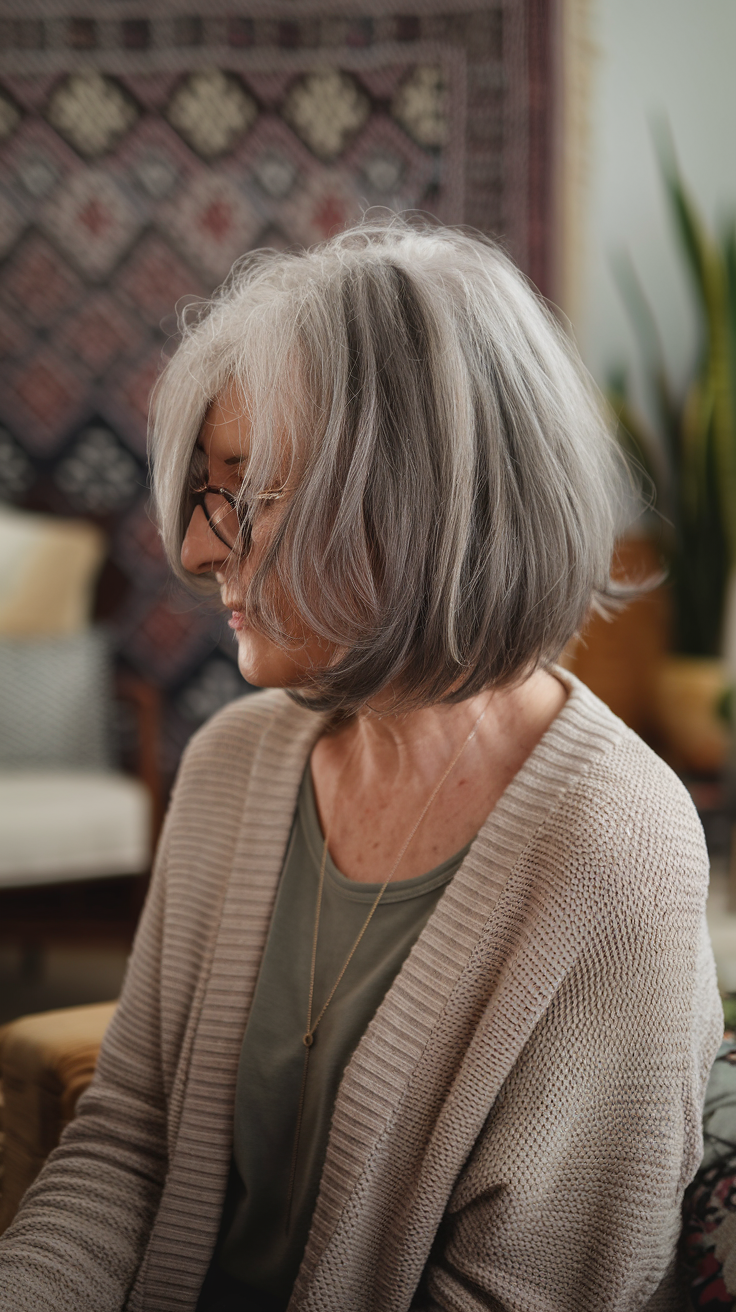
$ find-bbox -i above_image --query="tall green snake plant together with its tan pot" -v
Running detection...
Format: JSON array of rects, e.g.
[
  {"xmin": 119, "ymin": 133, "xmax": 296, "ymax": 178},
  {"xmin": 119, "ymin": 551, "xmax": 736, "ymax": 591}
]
[{"xmin": 610, "ymin": 133, "xmax": 736, "ymax": 773}]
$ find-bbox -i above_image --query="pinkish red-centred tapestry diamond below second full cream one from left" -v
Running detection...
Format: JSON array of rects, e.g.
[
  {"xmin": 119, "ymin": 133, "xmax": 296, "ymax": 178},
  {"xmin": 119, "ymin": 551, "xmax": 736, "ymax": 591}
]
[{"xmin": 165, "ymin": 172, "xmax": 262, "ymax": 278}]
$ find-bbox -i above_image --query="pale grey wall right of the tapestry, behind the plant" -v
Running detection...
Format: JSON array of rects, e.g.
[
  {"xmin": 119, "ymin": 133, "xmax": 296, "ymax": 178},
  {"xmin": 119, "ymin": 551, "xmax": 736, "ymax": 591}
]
[{"xmin": 572, "ymin": 0, "xmax": 736, "ymax": 401}]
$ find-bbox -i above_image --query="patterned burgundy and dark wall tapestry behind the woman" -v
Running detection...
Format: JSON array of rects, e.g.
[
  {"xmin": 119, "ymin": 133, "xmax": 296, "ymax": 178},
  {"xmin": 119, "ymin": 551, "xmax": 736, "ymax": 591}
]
[{"xmin": 0, "ymin": 0, "xmax": 552, "ymax": 773}]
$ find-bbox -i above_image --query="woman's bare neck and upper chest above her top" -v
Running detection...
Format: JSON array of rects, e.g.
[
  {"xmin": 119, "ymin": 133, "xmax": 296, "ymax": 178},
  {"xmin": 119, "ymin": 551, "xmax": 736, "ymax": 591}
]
[{"xmin": 311, "ymin": 672, "xmax": 567, "ymax": 883}]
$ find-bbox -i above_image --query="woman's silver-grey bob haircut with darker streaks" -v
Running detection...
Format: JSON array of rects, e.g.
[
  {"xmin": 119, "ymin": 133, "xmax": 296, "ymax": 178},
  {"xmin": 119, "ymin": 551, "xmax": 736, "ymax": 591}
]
[{"xmin": 151, "ymin": 218, "xmax": 626, "ymax": 714}]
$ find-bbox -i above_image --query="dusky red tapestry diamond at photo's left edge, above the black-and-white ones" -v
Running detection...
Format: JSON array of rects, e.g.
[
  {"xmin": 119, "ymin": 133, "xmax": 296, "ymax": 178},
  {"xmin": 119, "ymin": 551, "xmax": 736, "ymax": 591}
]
[{"xmin": 3, "ymin": 346, "xmax": 89, "ymax": 451}]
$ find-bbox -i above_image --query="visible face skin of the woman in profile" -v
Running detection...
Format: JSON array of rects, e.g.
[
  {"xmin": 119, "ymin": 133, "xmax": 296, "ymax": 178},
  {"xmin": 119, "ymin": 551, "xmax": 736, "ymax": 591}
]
[{"xmin": 181, "ymin": 391, "xmax": 336, "ymax": 687}]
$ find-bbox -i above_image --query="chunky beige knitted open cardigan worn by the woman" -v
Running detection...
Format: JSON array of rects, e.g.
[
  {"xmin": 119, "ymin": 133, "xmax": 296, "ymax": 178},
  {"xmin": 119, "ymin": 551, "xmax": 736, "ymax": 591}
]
[{"xmin": 0, "ymin": 676, "xmax": 723, "ymax": 1312}]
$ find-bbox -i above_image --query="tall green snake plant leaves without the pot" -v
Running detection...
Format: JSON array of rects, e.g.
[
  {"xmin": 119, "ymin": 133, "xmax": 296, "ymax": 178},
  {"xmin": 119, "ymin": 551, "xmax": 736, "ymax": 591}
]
[{"xmin": 610, "ymin": 129, "xmax": 736, "ymax": 656}]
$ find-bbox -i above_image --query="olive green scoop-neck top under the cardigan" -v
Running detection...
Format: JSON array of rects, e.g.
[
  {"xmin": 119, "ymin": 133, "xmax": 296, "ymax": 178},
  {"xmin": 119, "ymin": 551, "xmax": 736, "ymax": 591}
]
[{"xmin": 216, "ymin": 768, "xmax": 467, "ymax": 1307}]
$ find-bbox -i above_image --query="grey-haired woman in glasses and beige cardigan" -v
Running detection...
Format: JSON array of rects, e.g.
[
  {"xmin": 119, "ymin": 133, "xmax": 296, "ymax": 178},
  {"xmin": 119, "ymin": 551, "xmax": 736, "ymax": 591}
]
[{"xmin": 0, "ymin": 222, "xmax": 722, "ymax": 1312}]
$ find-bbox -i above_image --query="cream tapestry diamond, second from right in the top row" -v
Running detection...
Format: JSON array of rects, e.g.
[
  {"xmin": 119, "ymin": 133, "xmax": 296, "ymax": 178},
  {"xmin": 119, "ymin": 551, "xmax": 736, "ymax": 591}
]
[{"xmin": 282, "ymin": 68, "xmax": 370, "ymax": 160}]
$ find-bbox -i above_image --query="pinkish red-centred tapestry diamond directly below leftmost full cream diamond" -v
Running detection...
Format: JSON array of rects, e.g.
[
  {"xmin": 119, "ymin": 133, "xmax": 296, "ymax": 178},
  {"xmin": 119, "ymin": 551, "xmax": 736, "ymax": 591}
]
[{"xmin": 41, "ymin": 169, "xmax": 142, "ymax": 279}]
